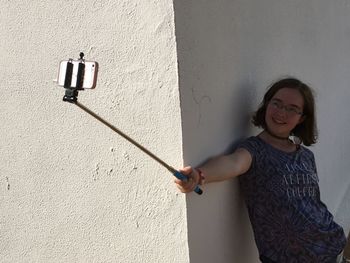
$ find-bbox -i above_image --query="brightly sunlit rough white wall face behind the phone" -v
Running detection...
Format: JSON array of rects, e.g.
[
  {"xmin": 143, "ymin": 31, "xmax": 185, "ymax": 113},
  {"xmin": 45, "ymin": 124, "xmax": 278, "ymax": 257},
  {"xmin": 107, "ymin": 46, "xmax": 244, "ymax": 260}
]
[{"xmin": 0, "ymin": 0, "xmax": 189, "ymax": 263}]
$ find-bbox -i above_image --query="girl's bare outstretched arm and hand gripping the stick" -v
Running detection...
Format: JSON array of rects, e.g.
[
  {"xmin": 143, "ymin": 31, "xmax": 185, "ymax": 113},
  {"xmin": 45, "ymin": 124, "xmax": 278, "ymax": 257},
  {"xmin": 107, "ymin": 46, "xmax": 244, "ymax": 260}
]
[{"xmin": 175, "ymin": 148, "xmax": 252, "ymax": 193}]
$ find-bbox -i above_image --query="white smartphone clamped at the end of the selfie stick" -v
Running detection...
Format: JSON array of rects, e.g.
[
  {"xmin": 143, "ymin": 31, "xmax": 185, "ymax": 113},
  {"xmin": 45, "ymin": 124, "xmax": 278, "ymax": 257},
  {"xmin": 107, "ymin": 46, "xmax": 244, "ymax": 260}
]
[{"xmin": 57, "ymin": 60, "xmax": 98, "ymax": 89}]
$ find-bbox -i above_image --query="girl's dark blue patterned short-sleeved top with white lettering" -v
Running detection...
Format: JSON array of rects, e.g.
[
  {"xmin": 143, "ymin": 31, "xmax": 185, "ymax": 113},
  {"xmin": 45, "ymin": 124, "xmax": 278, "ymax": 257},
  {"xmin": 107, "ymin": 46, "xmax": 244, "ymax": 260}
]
[{"xmin": 238, "ymin": 137, "xmax": 346, "ymax": 263}]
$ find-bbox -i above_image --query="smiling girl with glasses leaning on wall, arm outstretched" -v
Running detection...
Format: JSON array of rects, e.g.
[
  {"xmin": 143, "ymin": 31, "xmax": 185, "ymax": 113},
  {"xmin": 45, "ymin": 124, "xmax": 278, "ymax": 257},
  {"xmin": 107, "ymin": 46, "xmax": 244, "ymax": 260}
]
[{"xmin": 175, "ymin": 78, "xmax": 346, "ymax": 263}]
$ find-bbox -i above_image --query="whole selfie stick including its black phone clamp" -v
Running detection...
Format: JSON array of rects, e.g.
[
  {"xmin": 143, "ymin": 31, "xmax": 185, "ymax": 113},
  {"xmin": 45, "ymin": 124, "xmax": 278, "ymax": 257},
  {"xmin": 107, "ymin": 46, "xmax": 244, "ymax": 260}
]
[{"xmin": 63, "ymin": 53, "xmax": 203, "ymax": 195}]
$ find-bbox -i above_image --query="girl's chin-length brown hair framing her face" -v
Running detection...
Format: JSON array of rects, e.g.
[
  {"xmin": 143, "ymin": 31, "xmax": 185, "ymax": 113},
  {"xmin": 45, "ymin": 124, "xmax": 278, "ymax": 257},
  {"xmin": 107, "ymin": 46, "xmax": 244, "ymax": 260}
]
[{"xmin": 252, "ymin": 78, "xmax": 317, "ymax": 146}]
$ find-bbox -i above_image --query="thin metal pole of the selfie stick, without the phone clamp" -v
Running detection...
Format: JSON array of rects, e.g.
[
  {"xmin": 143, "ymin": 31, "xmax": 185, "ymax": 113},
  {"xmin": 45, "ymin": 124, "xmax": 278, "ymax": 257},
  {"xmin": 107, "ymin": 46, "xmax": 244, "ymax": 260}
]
[{"xmin": 74, "ymin": 100, "xmax": 203, "ymax": 195}]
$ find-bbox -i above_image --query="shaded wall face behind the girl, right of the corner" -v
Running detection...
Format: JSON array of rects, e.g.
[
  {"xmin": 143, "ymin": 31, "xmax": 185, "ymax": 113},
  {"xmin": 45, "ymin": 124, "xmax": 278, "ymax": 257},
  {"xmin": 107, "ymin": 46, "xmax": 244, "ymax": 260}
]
[{"xmin": 174, "ymin": 0, "xmax": 350, "ymax": 263}]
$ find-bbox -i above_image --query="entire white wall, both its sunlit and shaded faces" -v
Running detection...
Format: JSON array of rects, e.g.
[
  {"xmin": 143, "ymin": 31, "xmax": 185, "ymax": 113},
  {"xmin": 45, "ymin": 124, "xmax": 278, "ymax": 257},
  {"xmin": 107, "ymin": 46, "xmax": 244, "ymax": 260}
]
[{"xmin": 0, "ymin": 0, "xmax": 350, "ymax": 263}]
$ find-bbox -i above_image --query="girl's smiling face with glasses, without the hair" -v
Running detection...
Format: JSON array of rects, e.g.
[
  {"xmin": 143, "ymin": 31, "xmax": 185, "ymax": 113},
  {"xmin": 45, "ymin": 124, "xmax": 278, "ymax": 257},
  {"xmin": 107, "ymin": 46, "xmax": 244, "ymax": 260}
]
[{"xmin": 265, "ymin": 88, "xmax": 304, "ymax": 137}]
